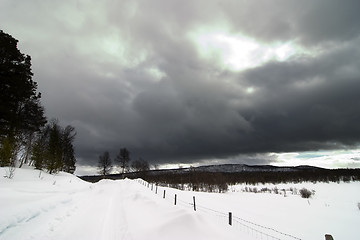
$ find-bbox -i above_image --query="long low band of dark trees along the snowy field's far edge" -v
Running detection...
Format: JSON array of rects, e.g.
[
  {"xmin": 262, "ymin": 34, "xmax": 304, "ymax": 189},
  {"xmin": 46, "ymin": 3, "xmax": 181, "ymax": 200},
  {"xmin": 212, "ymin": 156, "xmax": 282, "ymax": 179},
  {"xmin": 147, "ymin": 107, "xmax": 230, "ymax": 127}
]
[{"xmin": 141, "ymin": 168, "xmax": 360, "ymax": 192}]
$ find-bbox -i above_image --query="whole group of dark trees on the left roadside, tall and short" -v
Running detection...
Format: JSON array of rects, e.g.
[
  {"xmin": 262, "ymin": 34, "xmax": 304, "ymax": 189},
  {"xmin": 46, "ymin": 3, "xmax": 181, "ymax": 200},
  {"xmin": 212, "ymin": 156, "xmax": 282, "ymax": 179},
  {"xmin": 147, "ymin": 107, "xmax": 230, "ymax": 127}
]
[{"xmin": 0, "ymin": 30, "xmax": 76, "ymax": 177}]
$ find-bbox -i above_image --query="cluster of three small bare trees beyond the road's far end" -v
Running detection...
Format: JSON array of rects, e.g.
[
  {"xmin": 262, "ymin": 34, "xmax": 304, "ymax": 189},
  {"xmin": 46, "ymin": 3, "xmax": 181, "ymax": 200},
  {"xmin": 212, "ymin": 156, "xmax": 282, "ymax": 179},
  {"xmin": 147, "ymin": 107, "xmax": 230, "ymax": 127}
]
[{"xmin": 98, "ymin": 148, "xmax": 150, "ymax": 176}]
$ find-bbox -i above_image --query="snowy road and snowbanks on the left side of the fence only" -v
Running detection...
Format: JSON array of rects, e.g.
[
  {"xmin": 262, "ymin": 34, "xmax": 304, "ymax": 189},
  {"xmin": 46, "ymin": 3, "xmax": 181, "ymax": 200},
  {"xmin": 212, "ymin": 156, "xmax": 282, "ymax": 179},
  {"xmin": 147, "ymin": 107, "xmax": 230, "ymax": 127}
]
[{"xmin": 0, "ymin": 171, "xmax": 251, "ymax": 240}]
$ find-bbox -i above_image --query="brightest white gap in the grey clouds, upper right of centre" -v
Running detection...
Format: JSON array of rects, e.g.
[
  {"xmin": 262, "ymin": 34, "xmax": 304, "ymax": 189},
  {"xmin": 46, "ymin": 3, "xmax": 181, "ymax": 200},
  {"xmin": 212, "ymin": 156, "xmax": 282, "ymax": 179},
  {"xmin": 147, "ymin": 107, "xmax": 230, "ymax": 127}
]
[{"xmin": 189, "ymin": 31, "xmax": 304, "ymax": 71}]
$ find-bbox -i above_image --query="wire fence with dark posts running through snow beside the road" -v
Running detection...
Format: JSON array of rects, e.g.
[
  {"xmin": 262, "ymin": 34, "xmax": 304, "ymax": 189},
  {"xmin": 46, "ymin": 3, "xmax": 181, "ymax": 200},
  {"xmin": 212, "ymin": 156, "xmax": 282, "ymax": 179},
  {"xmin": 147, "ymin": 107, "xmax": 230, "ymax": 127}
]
[{"xmin": 137, "ymin": 179, "xmax": 301, "ymax": 240}]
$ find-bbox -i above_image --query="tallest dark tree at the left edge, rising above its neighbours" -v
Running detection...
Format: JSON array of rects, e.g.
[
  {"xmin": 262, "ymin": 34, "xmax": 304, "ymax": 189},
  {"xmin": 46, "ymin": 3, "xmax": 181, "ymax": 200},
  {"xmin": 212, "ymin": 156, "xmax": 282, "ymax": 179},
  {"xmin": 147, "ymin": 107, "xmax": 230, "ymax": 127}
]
[{"xmin": 0, "ymin": 30, "xmax": 46, "ymax": 166}]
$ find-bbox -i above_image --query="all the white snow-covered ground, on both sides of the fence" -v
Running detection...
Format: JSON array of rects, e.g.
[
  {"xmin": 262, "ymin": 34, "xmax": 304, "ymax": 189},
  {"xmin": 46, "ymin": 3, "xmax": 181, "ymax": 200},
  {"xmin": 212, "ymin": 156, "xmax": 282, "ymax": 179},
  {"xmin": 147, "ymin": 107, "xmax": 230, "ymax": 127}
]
[{"xmin": 0, "ymin": 168, "xmax": 360, "ymax": 240}]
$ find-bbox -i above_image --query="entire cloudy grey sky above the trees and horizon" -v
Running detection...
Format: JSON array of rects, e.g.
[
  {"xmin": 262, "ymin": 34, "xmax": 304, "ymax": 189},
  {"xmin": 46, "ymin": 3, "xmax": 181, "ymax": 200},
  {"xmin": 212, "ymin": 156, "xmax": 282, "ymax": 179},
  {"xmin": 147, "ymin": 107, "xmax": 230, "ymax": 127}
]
[{"xmin": 0, "ymin": 0, "xmax": 360, "ymax": 171}]
